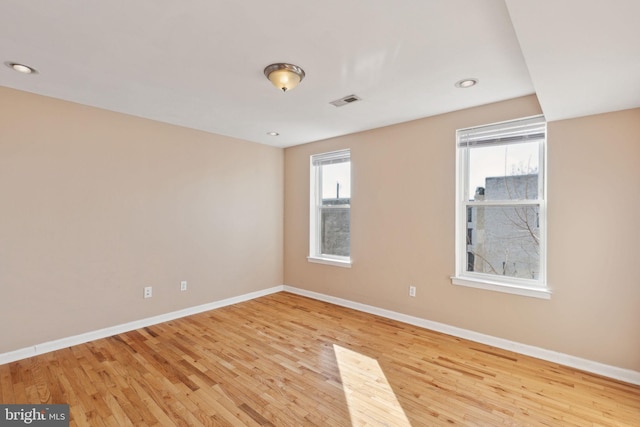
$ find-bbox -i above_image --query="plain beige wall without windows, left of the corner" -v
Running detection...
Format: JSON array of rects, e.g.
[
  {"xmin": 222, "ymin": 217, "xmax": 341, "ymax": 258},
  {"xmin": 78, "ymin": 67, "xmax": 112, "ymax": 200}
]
[{"xmin": 0, "ymin": 88, "xmax": 283, "ymax": 353}]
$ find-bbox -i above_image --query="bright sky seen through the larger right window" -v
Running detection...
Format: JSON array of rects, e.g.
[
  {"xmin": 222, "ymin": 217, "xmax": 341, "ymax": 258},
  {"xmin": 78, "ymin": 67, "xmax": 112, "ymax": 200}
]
[{"xmin": 468, "ymin": 142, "xmax": 540, "ymax": 200}]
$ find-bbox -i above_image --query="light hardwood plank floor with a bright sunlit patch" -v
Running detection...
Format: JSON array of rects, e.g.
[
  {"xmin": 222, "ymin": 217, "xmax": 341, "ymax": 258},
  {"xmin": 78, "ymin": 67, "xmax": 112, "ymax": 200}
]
[{"xmin": 0, "ymin": 292, "xmax": 640, "ymax": 427}]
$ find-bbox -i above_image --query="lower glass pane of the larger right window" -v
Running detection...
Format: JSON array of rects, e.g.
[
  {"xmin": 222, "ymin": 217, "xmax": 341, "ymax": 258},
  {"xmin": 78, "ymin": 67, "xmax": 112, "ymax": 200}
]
[{"xmin": 466, "ymin": 205, "xmax": 540, "ymax": 280}]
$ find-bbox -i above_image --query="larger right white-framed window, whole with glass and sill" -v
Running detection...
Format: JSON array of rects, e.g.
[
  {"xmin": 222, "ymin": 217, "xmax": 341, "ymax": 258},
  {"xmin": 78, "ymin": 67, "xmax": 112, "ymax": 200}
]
[{"xmin": 452, "ymin": 116, "xmax": 550, "ymax": 298}]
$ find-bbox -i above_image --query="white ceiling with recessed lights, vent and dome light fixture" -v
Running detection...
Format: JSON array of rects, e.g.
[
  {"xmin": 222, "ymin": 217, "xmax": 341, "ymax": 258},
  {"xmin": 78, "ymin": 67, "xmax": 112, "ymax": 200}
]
[{"xmin": 0, "ymin": 0, "xmax": 640, "ymax": 147}]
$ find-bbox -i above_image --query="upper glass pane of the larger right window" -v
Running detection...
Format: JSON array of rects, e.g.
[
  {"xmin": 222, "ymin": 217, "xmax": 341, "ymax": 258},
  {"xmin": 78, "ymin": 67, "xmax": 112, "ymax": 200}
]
[{"xmin": 468, "ymin": 142, "xmax": 540, "ymax": 200}]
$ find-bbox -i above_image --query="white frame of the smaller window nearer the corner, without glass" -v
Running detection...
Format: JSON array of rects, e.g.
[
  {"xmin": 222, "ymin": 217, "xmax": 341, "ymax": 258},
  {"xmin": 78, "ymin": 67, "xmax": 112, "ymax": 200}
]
[{"xmin": 307, "ymin": 149, "xmax": 351, "ymax": 268}]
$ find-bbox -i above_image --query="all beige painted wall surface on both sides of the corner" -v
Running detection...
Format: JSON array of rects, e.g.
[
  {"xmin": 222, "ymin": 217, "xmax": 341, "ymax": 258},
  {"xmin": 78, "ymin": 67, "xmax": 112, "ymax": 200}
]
[{"xmin": 0, "ymin": 88, "xmax": 640, "ymax": 371}]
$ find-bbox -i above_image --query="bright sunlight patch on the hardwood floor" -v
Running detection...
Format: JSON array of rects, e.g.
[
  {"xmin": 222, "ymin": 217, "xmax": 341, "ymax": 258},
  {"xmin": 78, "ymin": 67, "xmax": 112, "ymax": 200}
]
[{"xmin": 333, "ymin": 344, "xmax": 411, "ymax": 427}]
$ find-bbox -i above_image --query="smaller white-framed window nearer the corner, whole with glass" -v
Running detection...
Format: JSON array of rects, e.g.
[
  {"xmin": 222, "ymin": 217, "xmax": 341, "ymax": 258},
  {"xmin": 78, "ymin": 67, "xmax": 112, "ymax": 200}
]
[{"xmin": 308, "ymin": 150, "xmax": 351, "ymax": 267}]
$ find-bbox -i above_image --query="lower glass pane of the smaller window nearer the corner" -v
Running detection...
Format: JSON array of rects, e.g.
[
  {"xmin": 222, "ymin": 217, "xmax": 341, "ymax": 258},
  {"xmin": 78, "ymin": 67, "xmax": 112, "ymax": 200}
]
[{"xmin": 320, "ymin": 207, "xmax": 351, "ymax": 256}]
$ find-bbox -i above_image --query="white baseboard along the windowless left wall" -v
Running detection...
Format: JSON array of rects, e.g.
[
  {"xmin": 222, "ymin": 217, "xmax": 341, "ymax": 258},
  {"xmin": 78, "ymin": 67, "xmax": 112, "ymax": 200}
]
[{"xmin": 0, "ymin": 285, "xmax": 283, "ymax": 365}]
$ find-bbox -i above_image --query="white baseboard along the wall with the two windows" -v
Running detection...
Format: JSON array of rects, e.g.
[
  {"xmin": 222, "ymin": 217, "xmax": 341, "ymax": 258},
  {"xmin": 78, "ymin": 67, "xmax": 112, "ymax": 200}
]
[{"xmin": 284, "ymin": 285, "xmax": 640, "ymax": 385}]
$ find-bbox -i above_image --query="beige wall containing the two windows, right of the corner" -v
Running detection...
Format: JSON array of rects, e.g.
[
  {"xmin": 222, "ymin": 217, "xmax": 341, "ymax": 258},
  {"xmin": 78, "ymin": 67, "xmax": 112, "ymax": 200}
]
[{"xmin": 284, "ymin": 96, "xmax": 640, "ymax": 371}]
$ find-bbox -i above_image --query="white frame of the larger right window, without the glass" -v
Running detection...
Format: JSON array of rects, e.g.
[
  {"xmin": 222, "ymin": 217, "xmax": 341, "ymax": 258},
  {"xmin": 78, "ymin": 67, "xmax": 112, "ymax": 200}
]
[{"xmin": 451, "ymin": 116, "xmax": 551, "ymax": 299}]
